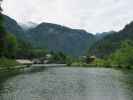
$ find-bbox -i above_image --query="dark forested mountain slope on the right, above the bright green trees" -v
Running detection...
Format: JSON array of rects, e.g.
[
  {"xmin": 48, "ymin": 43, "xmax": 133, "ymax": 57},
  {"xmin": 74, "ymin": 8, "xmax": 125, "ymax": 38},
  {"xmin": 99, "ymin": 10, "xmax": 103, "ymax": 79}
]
[{"xmin": 88, "ymin": 22, "xmax": 133, "ymax": 58}]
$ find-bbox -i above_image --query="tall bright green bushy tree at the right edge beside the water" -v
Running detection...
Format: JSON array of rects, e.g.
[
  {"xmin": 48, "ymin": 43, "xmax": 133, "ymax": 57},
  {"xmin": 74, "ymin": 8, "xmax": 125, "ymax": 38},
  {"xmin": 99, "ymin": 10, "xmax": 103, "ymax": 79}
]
[{"xmin": 109, "ymin": 40, "xmax": 133, "ymax": 67}]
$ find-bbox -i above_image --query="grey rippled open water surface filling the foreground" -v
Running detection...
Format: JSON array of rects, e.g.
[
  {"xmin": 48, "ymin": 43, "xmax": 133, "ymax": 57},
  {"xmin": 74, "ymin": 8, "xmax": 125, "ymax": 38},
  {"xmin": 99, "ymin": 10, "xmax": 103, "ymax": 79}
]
[{"xmin": 0, "ymin": 68, "xmax": 133, "ymax": 100}]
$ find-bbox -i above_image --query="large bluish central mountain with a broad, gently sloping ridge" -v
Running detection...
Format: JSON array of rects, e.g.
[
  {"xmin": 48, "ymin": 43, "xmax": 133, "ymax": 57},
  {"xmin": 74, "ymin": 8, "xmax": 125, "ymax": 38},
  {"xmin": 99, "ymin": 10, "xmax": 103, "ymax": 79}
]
[{"xmin": 27, "ymin": 23, "xmax": 94, "ymax": 56}]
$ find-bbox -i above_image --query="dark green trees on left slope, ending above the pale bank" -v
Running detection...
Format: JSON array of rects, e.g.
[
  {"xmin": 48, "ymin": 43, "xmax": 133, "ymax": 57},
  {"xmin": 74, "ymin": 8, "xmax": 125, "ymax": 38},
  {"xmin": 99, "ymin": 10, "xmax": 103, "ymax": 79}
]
[{"xmin": 0, "ymin": 14, "xmax": 47, "ymax": 59}]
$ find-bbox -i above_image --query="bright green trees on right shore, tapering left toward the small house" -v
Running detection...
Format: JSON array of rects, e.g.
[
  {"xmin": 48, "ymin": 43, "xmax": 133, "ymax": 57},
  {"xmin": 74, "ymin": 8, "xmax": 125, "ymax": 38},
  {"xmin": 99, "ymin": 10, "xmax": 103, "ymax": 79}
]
[{"xmin": 84, "ymin": 40, "xmax": 133, "ymax": 69}]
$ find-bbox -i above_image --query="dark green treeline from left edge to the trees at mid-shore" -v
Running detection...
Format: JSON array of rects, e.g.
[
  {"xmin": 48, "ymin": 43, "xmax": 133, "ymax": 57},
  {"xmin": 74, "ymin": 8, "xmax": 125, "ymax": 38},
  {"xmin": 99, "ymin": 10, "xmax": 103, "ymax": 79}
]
[{"xmin": 0, "ymin": 15, "xmax": 71, "ymax": 63}]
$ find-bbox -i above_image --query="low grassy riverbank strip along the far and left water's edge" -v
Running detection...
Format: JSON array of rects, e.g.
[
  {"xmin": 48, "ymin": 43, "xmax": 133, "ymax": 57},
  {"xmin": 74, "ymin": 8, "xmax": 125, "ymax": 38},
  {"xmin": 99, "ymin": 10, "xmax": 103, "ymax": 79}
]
[{"xmin": 0, "ymin": 58, "xmax": 133, "ymax": 81}]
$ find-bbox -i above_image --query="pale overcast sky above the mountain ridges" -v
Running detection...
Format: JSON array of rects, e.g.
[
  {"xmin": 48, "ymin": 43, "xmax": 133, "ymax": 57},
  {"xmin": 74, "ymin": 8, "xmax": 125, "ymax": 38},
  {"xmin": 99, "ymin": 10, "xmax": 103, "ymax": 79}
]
[{"xmin": 2, "ymin": 0, "xmax": 133, "ymax": 33}]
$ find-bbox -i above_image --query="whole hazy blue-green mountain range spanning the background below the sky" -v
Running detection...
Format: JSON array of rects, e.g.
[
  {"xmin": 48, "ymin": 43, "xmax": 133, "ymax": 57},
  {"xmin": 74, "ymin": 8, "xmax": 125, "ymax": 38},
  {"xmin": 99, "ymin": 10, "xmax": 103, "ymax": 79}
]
[{"xmin": 2, "ymin": 16, "xmax": 133, "ymax": 57}]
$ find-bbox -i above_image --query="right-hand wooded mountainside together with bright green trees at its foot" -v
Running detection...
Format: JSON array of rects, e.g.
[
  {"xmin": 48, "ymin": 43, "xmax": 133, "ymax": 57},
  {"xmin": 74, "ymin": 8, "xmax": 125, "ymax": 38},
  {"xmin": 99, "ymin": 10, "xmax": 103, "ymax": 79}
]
[{"xmin": 87, "ymin": 18, "xmax": 133, "ymax": 68}]
